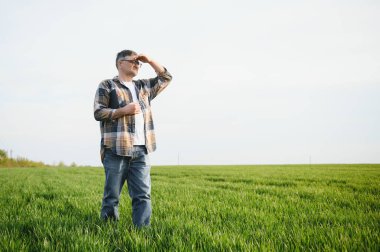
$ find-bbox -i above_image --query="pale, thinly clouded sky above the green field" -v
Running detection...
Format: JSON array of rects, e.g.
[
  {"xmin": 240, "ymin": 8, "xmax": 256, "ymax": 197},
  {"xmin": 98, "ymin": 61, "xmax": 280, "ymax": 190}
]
[{"xmin": 0, "ymin": 0, "xmax": 380, "ymax": 166}]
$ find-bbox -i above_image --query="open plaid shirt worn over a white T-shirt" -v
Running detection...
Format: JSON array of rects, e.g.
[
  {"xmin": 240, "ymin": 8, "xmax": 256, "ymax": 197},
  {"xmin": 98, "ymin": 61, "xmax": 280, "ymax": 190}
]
[{"xmin": 94, "ymin": 69, "xmax": 172, "ymax": 162}]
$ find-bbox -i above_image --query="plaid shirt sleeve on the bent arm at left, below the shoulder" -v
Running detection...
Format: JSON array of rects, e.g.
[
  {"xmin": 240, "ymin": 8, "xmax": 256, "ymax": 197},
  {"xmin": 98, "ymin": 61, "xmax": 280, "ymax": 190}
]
[{"xmin": 94, "ymin": 82, "xmax": 115, "ymax": 121}]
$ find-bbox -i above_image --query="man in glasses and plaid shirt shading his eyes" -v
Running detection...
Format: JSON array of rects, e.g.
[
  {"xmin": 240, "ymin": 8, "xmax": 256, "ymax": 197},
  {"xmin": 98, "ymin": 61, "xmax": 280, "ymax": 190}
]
[{"xmin": 94, "ymin": 50, "xmax": 172, "ymax": 227}]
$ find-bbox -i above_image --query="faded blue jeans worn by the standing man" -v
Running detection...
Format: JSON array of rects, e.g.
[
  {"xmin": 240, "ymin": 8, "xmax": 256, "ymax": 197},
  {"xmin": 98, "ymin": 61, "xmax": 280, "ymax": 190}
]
[{"xmin": 100, "ymin": 146, "xmax": 152, "ymax": 227}]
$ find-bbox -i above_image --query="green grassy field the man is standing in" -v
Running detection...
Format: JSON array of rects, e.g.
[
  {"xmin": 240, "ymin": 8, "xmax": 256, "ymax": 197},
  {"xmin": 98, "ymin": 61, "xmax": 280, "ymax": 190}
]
[{"xmin": 0, "ymin": 165, "xmax": 380, "ymax": 251}]
